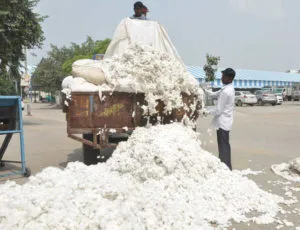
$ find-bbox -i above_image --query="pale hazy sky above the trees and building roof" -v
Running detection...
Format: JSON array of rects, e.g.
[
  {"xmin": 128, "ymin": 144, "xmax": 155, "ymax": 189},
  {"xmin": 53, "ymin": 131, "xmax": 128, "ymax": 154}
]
[{"xmin": 28, "ymin": 0, "xmax": 300, "ymax": 71}]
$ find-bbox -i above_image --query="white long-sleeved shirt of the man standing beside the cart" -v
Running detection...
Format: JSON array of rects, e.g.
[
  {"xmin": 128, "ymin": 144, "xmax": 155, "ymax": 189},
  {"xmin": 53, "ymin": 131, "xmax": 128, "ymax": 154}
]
[{"xmin": 205, "ymin": 84, "xmax": 235, "ymax": 131}]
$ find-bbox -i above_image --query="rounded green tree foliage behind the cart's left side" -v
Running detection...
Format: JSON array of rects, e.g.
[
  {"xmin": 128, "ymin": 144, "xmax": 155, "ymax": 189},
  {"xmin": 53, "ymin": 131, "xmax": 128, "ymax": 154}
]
[{"xmin": 33, "ymin": 36, "xmax": 110, "ymax": 93}]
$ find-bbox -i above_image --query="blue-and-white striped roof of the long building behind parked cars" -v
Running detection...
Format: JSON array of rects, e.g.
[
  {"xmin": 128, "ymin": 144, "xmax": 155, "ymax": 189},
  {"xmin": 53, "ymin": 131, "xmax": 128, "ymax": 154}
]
[{"xmin": 187, "ymin": 66, "xmax": 300, "ymax": 82}]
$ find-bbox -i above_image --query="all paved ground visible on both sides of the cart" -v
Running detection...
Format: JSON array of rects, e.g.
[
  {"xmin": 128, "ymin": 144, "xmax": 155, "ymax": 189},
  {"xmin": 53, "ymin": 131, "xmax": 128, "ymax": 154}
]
[{"xmin": 0, "ymin": 102, "xmax": 300, "ymax": 229}]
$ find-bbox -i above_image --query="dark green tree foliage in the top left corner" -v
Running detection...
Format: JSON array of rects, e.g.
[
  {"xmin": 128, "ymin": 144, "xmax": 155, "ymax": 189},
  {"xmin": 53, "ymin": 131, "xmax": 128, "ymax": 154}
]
[{"xmin": 0, "ymin": 0, "xmax": 45, "ymax": 78}]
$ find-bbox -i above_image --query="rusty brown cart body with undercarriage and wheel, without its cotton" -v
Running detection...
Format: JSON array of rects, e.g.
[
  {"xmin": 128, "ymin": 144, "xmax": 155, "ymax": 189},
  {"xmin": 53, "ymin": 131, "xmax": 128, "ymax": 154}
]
[{"xmin": 63, "ymin": 92, "xmax": 201, "ymax": 165}]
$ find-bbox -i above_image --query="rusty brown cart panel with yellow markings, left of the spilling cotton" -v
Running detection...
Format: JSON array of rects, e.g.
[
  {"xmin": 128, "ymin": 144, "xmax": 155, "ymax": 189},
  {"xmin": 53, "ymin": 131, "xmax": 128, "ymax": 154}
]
[{"xmin": 68, "ymin": 92, "xmax": 148, "ymax": 130}]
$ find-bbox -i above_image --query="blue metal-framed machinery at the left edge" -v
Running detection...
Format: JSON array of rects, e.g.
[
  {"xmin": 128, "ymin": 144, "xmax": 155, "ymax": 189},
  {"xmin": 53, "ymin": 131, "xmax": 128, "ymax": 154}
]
[{"xmin": 0, "ymin": 96, "xmax": 30, "ymax": 177}]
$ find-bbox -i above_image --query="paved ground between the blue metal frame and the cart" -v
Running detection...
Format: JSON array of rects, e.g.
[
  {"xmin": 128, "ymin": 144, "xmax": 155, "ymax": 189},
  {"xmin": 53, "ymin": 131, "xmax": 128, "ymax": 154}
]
[{"xmin": 1, "ymin": 104, "xmax": 82, "ymax": 183}]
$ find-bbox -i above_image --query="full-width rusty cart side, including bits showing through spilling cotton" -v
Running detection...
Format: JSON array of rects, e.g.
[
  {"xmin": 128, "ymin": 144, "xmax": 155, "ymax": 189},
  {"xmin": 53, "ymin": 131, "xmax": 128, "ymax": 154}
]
[{"xmin": 67, "ymin": 92, "xmax": 201, "ymax": 133}]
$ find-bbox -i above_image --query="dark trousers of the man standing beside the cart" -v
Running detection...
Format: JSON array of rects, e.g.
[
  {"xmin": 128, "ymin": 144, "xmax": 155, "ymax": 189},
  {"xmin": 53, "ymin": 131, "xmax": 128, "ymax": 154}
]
[{"xmin": 217, "ymin": 129, "xmax": 232, "ymax": 170}]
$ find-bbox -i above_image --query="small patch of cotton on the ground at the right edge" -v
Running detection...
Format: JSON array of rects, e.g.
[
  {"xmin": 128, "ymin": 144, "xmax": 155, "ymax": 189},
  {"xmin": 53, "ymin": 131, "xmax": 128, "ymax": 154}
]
[{"xmin": 271, "ymin": 157, "xmax": 300, "ymax": 182}]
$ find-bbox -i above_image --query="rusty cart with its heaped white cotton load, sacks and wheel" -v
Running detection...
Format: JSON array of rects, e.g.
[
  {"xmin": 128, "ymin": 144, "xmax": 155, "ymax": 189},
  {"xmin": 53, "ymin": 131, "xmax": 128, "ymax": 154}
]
[{"xmin": 62, "ymin": 18, "xmax": 203, "ymax": 164}]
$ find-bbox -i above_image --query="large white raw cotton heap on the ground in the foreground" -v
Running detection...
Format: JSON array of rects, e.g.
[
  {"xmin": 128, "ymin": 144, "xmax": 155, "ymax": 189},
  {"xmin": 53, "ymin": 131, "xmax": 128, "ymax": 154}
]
[{"xmin": 0, "ymin": 123, "xmax": 284, "ymax": 230}]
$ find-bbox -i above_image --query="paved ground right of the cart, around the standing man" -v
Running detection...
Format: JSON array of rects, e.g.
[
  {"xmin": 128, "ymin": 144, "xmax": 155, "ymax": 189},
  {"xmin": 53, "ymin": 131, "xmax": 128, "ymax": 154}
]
[{"xmin": 197, "ymin": 102, "xmax": 300, "ymax": 229}]
